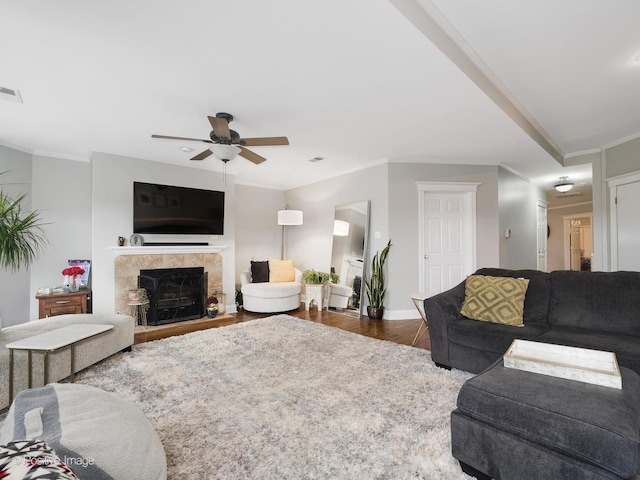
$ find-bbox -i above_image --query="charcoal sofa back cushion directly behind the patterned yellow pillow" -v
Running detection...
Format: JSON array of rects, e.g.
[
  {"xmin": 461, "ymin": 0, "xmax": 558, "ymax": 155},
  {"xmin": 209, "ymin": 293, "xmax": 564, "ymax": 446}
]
[{"xmin": 476, "ymin": 268, "xmax": 551, "ymax": 325}]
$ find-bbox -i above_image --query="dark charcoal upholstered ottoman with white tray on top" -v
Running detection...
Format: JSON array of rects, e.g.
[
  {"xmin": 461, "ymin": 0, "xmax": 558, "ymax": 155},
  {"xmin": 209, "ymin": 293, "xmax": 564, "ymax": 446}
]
[{"xmin": 451, "ymin": 359, "xmax": 640, "ymax": 480}]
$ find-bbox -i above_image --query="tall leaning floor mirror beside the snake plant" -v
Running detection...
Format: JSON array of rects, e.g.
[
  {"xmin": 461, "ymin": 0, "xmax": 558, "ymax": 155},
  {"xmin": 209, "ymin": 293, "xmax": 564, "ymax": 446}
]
[{"xmin": 327, "ymin": 200, "xmax": 370, "ymax": 318}]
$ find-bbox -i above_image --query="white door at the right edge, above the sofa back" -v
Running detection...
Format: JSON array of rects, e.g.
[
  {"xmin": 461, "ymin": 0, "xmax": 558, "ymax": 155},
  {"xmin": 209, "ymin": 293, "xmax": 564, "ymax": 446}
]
[{"xmin": 615, "ymin": 182, "xmax": 640, "ymax": 271}]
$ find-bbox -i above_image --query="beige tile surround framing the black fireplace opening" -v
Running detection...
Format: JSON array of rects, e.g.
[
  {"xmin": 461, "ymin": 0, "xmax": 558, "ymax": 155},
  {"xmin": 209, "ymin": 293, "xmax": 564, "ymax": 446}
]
[{"xmin": 114, "ymin": 249, "xmax": 223, "ymax": 313}]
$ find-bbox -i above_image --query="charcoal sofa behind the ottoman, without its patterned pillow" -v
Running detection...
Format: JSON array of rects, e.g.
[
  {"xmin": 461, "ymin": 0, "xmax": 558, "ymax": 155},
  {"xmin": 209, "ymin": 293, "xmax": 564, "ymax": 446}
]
[{"xmin": 424, "ymin": 268, "xmax": 640, "ymax": 373}]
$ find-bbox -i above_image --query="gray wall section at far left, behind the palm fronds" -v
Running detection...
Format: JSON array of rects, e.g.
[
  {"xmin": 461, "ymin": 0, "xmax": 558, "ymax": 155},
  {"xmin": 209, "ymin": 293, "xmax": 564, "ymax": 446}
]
[{"xmin": 0, "ymin": 146, "xmax": 33, "ymax": 327}]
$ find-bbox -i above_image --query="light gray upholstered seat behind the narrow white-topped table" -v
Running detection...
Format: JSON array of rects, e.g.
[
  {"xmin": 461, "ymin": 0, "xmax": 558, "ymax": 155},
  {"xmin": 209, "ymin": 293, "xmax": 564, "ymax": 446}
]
[{"xmin": 0, "ymin": 314, "xmax": 135, "ymax": 409}]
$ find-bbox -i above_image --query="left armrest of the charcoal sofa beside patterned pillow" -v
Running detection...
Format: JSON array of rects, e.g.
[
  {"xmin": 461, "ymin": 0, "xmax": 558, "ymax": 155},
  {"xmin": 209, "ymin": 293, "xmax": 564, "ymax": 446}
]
[{"xmin": 424, "ymin": 282, "xmax": 465, "ymax": 366}]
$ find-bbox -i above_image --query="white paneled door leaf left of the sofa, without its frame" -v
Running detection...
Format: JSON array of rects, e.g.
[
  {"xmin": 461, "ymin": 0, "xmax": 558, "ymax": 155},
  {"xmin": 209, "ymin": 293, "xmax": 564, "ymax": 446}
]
[{"xmin": 422, "ymin": 192, "xmax": 475, "ymax": 296}]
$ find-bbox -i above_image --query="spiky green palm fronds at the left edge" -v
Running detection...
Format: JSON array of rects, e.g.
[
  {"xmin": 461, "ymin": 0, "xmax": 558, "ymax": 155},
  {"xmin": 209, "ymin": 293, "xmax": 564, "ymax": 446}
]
[{"xmin": 0, "ymin": 172, "xmax": 47, "ymax": 272}]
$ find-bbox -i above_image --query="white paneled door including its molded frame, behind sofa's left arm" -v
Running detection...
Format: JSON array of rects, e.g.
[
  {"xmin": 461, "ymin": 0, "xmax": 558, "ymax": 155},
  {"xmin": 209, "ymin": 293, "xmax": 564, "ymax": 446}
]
[{"xmin": 418, "ymin": 182, "xmax": 479, "ymax": 296}]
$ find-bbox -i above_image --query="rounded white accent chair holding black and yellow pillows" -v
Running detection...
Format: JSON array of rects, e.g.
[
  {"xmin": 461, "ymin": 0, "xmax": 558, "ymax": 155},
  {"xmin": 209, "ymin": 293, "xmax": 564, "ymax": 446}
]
[{"xmin": 240, "ymin": 268, "xmax": 302, "ymax": 313}]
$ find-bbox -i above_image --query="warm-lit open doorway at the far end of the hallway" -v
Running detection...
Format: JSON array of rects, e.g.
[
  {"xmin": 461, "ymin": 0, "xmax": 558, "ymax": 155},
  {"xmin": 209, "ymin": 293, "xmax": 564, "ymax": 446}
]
[{"xmin": 562, "ymin": 213, "xmax": 593, "ymax": 271}]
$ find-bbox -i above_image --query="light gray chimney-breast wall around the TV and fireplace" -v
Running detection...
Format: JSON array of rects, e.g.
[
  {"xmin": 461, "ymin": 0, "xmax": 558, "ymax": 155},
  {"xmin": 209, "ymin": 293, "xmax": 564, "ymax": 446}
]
[{"xmin": 91, "ymin": 153, "xmax": 236, "ymax": 313}]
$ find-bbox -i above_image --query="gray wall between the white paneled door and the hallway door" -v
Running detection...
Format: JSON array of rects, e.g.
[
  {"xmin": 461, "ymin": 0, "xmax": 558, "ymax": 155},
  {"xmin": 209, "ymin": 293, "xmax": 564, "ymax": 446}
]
[{"xmin": 498, "ymin": 168, "xmax": 546, "ymax": 269}]
